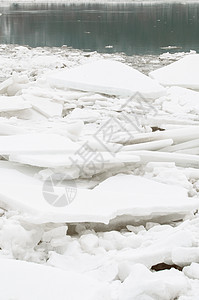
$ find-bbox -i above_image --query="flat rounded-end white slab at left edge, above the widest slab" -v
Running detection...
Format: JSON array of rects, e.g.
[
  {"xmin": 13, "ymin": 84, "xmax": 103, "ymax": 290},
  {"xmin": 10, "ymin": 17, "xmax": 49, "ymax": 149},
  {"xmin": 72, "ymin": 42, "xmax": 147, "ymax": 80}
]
[{"xmin": 0, "ymin": 133, "xmax": 79, "ymax": 155}]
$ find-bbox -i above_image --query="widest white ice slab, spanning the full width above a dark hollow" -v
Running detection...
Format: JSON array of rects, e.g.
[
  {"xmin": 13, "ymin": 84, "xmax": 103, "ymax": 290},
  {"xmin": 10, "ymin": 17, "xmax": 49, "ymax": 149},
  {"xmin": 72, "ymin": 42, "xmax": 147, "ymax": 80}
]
[{"xmin": 0, "ymin": 162, "xmax": 199, "ymax": 224}]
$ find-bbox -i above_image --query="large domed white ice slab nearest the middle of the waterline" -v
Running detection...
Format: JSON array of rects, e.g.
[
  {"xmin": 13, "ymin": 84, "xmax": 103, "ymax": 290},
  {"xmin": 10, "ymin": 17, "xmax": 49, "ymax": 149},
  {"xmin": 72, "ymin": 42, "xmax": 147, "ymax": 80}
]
[{"xmin": 47, "ymin": 60, "xmax": 166, "ymax": 99}]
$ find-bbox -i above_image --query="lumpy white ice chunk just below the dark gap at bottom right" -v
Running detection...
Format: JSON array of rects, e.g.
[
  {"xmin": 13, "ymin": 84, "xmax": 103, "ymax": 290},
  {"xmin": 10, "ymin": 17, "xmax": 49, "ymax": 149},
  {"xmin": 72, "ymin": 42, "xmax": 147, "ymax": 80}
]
[{"xmin": 119, "ymin": 264, "xmax": 189, "ymax": 300}]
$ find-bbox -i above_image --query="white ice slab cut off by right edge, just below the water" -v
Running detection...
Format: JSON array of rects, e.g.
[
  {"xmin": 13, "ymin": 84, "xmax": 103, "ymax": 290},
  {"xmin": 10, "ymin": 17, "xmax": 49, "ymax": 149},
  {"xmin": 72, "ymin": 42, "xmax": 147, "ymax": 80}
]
[{"xmin": 149, "ymin": 54, "xmax": 199, "ymax": 90}]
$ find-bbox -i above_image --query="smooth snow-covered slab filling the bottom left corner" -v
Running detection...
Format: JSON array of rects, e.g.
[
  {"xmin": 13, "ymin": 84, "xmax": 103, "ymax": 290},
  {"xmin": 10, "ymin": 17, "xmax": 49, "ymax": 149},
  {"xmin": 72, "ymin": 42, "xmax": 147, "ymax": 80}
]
[{"xmin": 0, "ymin": 258, "xmax": 110, "ymax": 300}]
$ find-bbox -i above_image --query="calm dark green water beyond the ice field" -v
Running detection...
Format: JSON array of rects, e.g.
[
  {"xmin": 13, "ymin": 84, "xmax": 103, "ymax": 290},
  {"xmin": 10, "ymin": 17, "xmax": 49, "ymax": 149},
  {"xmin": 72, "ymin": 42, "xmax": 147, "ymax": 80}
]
[{"xmin": 0, "ymin": 3, "xmax": 199, "ymax": 55}]
